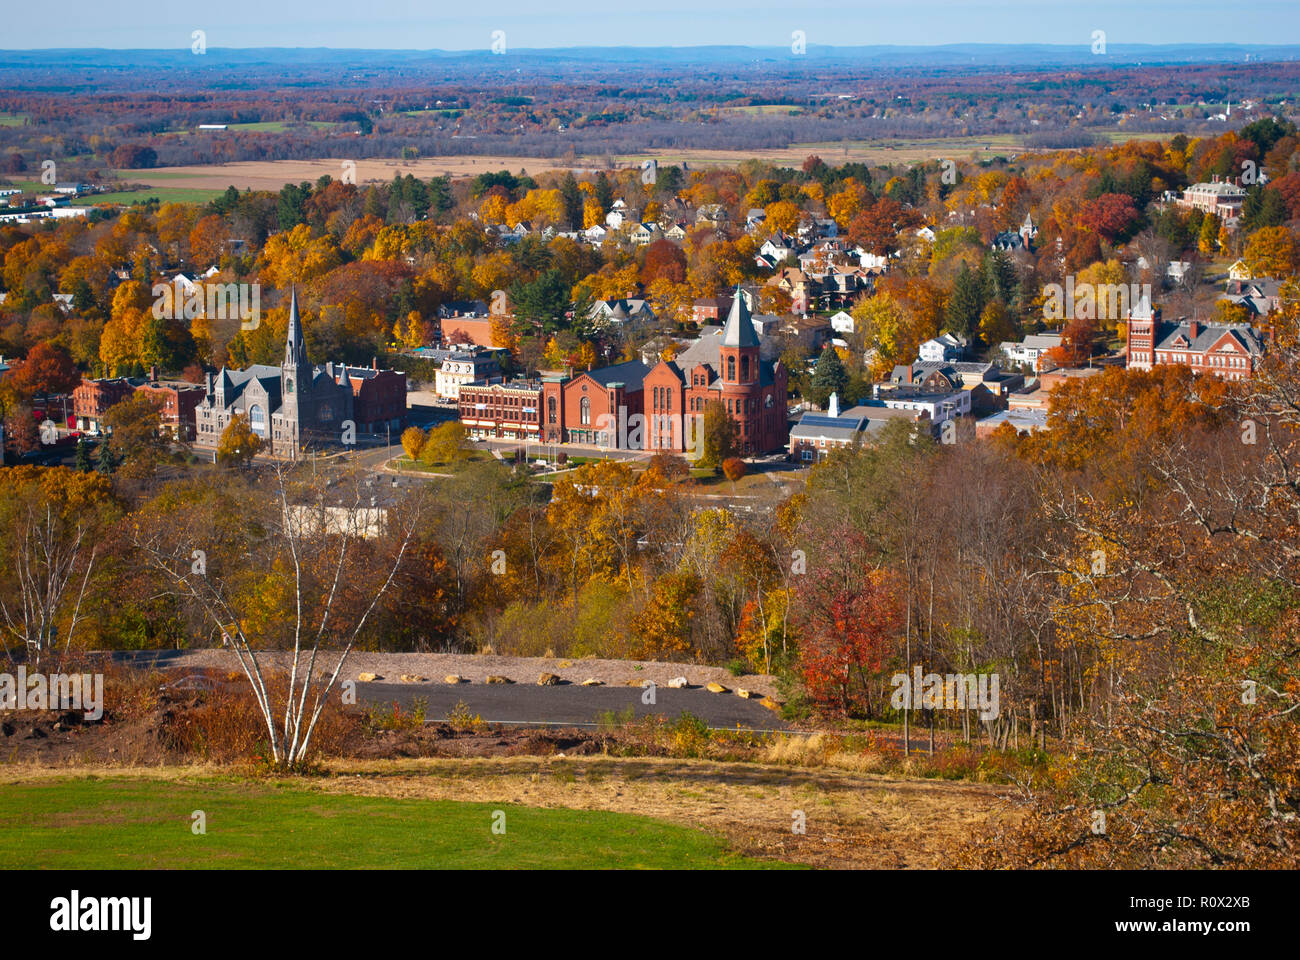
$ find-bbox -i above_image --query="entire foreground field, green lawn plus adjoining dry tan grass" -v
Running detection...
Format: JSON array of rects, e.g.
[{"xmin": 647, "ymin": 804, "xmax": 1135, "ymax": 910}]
[{"xmin": 0, "ymin": 756, "xmax": 1011, "ymax": 869}]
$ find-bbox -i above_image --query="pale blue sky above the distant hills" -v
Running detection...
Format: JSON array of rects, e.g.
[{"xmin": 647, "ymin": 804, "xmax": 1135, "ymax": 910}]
[{"xmin": 10, "ymin": 0, "xmax": 1300, "ymax": 49}]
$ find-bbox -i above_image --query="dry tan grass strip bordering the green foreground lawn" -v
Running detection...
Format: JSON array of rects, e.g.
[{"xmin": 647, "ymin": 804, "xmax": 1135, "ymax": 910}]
[{"xmin": 316, "ymin": 757, "xmax": 1006, "ymax": 869}]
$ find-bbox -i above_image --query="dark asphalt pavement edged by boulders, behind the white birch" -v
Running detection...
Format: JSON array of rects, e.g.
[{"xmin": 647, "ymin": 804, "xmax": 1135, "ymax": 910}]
[{"xmin": 356, "ymin": 683, "xmax": 787, "ymax": 730}]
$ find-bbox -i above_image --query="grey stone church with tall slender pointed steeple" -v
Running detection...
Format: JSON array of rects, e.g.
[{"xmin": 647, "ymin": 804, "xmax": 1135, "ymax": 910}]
[{"xmin": 194, "ymin": 290, "xmax": 356, "ymax": 457}]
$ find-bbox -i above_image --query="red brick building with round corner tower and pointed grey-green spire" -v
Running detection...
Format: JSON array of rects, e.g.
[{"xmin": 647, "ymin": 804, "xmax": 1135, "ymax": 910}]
[{"xmin": 644, "ymin": 290, "xmax": 789, "ymax": 455}]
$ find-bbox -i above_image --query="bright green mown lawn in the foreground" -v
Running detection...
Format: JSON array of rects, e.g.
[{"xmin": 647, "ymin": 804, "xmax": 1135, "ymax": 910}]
[{"xmin": 0, "ymin": 778, "xmax": 789, "ymax": 869}]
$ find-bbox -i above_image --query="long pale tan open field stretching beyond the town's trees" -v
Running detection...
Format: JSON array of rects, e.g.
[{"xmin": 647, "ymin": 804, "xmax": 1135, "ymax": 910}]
[{"xmin": 116, "ymin": 131, "xmax": 1185, "ymax": 190}]
